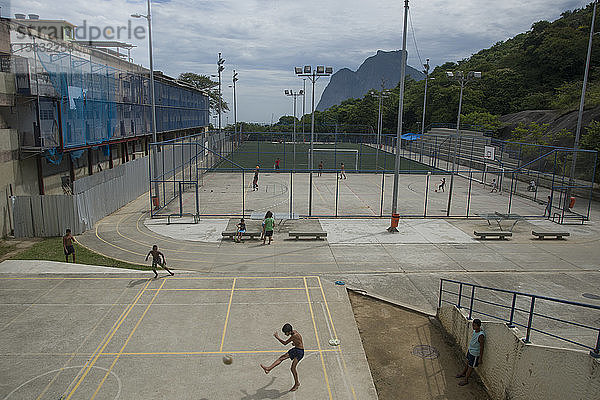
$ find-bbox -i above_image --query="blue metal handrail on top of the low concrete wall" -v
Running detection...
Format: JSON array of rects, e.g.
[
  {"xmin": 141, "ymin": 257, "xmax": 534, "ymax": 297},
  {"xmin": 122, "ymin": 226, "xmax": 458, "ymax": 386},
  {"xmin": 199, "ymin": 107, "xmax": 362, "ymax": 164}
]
[{"xmin": 438, "ymin": 278, "xmax": 600, "ymax": 358}]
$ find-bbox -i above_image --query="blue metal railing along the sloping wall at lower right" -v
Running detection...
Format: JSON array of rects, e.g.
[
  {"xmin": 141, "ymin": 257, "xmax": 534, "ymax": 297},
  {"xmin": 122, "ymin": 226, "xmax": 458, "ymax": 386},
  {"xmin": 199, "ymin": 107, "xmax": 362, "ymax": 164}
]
[{"xmin": 438, "ymin": 279, "xmax": 600, "ymax": 358}]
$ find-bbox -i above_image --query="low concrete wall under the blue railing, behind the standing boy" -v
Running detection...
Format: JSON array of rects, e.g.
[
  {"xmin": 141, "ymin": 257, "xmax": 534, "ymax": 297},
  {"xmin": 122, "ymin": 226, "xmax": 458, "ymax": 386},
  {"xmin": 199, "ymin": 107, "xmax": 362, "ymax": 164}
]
[{"xmin": 437, "ymin": 305, "xmax": 600, "ymax": 400}]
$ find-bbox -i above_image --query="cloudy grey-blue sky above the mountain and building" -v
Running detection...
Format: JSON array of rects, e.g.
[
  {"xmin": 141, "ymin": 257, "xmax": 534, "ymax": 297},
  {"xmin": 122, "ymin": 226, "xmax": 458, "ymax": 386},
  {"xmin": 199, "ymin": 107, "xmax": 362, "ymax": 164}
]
[{"xmin": 0, "ymin": 0, "xmax": 590, "ymax": 124}]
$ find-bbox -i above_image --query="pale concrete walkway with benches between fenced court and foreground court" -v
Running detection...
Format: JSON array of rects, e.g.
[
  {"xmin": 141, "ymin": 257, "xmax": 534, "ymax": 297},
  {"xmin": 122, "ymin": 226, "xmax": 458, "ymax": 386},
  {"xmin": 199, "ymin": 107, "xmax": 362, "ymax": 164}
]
[{"xmin": 77, "ymin": 188, "xmax": 600, "ymax": 354}]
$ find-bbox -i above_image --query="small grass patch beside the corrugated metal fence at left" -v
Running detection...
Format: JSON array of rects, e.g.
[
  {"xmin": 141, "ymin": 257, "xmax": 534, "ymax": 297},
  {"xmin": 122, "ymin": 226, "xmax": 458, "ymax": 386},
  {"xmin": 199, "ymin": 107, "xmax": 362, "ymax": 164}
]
[{"xmin": 11, "ymin": 237, "xmax": 152, "ymax": 271}]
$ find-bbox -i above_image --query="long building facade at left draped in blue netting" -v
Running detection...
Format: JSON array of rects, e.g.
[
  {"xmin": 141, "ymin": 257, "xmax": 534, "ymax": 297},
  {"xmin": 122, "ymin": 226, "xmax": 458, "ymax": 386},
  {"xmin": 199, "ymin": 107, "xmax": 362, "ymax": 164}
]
[{"xmin": 0, "ymin": 19, "xmax": 209, "ymax": 236}]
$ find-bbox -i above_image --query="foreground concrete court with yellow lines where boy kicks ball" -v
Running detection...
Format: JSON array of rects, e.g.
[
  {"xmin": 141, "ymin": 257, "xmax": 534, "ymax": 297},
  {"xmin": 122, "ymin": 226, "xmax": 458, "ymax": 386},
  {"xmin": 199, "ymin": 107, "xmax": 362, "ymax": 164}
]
[{"xmin": 0, "ymin": 273, "xmax": 377, "ymax": 399}]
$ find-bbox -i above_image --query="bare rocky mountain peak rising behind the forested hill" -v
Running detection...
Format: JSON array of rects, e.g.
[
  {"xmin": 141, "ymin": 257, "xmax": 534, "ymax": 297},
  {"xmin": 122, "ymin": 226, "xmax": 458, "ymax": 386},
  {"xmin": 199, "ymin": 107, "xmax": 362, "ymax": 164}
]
[{"xmin": 317, "ymin": 50, "xmax": 425, "ymax": 111}]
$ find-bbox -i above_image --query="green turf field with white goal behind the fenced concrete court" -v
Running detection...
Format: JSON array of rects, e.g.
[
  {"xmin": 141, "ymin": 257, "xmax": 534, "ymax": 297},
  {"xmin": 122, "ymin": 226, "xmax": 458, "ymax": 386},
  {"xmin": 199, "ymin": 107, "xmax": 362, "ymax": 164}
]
[{"xmin": 217, "ymin": 141, "xmax": 437, "ymax": 172}]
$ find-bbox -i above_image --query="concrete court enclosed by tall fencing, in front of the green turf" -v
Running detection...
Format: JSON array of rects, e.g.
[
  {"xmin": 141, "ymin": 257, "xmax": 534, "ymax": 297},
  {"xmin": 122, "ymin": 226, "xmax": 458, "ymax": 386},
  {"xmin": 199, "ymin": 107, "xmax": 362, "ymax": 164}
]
[{"xmin": 161, "ymin": 172, "xmax": 597, "ymax": 217}]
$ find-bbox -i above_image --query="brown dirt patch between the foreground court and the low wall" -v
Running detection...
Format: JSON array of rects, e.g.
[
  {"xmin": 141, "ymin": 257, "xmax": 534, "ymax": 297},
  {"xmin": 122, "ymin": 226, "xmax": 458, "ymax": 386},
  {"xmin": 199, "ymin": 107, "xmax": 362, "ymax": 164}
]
[{"xmin": 349, "ymin": 292, "xmax": 489, "ymax": 400}]
